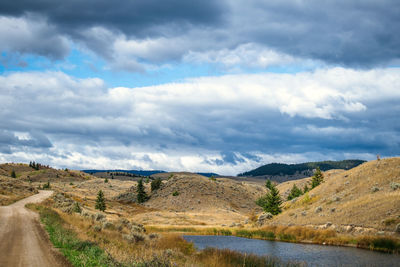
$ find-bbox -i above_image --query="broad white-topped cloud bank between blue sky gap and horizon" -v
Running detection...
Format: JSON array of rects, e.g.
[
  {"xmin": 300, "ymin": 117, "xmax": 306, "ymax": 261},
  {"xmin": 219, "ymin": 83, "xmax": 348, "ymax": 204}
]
[{"xmin": 0, "ymin": 68, "xmax": 400, "ymax": 174}]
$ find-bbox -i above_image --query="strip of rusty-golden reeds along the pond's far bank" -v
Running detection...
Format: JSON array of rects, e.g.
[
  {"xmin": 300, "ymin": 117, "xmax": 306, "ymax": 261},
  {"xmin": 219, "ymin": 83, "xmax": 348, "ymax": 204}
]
[{"xmin": 148, "ymin": 226, "xmax": 400, "ymax": 253}]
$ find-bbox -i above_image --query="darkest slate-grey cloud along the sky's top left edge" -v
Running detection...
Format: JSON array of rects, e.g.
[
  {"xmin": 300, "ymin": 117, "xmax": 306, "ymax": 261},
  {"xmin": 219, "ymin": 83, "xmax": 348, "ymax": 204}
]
[{"xmin": 0, "ymin": 0, "xmax": 223, "ymax": 37}]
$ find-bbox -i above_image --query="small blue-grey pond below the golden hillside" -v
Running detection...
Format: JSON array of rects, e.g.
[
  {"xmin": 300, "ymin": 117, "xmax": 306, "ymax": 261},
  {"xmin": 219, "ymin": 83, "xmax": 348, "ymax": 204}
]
[{"xmin": 183, "ymin": 235, "xmax": 400, "ymax": 267}]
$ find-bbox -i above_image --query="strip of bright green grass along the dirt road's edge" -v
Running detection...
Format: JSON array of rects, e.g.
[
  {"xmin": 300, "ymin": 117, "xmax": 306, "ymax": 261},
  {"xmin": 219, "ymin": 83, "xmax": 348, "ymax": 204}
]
[{"xmin": 37, "ymin": 206, "xmax": 116, "ymax": 267}]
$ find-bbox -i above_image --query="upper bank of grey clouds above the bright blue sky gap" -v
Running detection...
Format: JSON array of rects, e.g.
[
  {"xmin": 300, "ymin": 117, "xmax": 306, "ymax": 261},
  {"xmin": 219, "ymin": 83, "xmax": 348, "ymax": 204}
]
[{"xmin": 0, "ymin": 0, "xmax": 400, "ymax": 72}]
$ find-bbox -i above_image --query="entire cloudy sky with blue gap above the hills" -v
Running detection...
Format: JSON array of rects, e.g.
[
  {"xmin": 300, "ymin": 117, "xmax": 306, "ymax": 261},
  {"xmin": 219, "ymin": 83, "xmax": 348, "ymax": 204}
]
[{"xmin": 0, "ymin": 0, "xmax": 400, "ymax": 175}]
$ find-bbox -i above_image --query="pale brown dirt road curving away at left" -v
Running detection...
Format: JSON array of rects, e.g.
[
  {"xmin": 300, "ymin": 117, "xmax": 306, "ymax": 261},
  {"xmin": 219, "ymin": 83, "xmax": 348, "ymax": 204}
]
[{"xmin": 0, "ymin": 191, "xmax": 66, "ymax": 267}]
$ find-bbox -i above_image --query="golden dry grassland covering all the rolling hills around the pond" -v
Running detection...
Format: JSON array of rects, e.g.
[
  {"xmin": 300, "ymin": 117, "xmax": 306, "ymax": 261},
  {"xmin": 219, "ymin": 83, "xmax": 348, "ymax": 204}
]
[{"xmin": 0, "ymin": 158, "xmax": 400, "ymax": 264}]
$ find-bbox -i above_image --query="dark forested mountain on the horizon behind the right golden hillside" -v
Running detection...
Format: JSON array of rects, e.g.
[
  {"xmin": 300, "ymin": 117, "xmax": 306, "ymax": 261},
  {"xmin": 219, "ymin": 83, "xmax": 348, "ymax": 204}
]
[{"xmin": 238, "ymin": 159, "xmax": 365, "ymax": 181}]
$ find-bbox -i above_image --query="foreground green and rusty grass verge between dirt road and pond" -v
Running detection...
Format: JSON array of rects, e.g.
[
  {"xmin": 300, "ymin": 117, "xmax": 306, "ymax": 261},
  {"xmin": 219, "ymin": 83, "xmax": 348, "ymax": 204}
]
[{"xmin": 27, "ymin": 204, "xmax": 300, "ymax": 267}]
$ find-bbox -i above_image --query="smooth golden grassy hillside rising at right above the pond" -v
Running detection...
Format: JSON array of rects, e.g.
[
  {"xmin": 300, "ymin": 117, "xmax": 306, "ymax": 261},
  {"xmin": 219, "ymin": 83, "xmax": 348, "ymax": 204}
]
[{"xmin": 269, "ymin": 158, "xmax": 400, "ymax": 233}]
